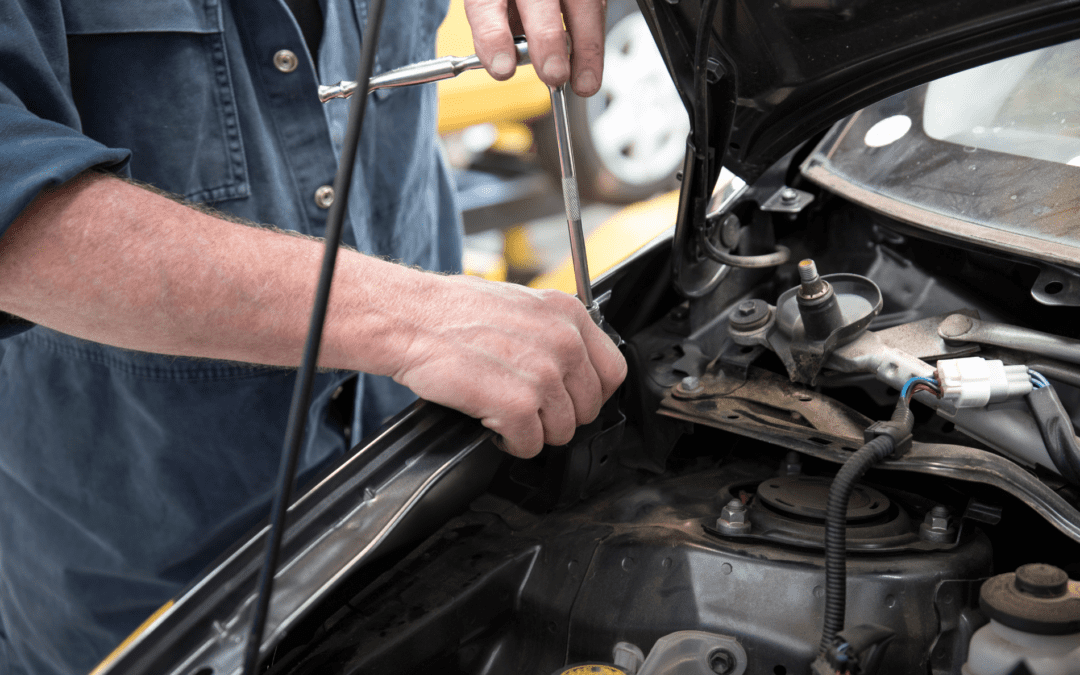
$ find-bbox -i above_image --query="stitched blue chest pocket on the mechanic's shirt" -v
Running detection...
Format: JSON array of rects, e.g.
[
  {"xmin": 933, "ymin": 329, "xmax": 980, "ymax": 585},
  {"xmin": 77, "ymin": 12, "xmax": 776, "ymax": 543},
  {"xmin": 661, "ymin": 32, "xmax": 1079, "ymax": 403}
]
[{"xmin": 64, "ymin": 0, "xmax": 251, "ymax": 202}]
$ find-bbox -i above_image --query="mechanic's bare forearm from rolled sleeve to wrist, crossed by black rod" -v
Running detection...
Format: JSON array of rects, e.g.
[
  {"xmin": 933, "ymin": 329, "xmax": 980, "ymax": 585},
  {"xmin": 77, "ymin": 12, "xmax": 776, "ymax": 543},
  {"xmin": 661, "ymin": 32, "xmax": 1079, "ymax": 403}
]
[{"xmin": 0, "ymin": 167, "xmax": 423, "ymax": 374}]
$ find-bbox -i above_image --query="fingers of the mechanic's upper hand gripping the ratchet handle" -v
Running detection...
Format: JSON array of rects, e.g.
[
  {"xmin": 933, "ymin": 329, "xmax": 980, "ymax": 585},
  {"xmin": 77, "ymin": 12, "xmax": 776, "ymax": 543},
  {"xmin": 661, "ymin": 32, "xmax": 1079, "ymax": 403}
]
[{"xmin": 465, "ymin": 0, "xmax": 607, "ymax": 96}]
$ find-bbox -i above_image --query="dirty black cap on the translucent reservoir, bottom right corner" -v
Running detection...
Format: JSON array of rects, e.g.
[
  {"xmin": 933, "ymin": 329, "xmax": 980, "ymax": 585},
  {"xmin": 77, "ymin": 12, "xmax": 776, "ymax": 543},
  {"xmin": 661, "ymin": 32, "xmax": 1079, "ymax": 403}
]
[{"xmin": 978, "ymin": 563, "xmax": 1080, "ymax": 635}]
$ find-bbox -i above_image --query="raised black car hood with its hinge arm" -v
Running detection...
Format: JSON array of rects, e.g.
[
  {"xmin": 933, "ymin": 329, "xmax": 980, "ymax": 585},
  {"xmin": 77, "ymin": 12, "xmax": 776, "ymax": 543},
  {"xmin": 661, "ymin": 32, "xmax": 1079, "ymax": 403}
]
[{"xmin": 638, "ymin": 0, "xmax": 1080, "ymax": 298}]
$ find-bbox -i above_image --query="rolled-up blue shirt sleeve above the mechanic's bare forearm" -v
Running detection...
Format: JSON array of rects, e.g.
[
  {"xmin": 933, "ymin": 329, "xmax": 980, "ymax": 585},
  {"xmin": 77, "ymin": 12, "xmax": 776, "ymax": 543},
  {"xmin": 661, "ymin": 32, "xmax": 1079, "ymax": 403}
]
[{"xmin": 0, "ymin": 0, "xmax": 130, "ymax": 338}]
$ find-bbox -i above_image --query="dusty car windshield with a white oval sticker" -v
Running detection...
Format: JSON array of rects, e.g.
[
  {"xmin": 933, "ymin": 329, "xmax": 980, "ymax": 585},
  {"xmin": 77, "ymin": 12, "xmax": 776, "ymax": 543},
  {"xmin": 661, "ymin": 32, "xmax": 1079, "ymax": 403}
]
[{"xmin": 801, "ymin": 36, "xmax": 1080, "ymax": 270}]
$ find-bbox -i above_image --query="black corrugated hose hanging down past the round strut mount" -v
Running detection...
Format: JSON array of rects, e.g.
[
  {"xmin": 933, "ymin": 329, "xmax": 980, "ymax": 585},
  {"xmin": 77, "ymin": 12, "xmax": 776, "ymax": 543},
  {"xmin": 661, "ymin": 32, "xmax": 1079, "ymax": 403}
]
[{"xmin": 821, "ymin": 397, "xmax": 915, "ymax": 653}]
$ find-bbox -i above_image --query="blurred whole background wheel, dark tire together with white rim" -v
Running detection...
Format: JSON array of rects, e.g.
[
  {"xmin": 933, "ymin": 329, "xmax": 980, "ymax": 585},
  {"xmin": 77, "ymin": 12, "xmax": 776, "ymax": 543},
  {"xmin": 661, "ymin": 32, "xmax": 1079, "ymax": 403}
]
[{"xmin": 537, "ymin": 0, "xmax": 690, "ymax": 203}]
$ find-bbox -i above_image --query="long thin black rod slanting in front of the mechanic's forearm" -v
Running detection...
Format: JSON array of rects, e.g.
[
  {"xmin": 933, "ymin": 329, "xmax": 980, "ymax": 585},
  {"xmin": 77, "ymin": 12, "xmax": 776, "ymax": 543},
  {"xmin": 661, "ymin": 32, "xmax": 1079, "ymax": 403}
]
[{"xmin": 242, "ymin": 0, "xmax": 386, "ymax": 675}]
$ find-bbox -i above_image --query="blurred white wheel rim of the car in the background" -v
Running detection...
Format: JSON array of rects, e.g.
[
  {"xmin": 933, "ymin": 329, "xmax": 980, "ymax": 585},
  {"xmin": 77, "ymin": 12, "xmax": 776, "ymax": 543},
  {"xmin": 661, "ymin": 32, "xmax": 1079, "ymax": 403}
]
[{"xmin": 585, "ymin": 12, "xmax": 690, "ymax": 187}]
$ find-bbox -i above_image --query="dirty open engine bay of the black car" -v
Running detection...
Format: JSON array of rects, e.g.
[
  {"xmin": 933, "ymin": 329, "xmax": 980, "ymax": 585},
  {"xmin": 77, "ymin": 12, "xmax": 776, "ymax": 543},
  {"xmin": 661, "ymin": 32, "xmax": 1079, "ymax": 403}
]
[{"xmin": 259, "ymin": 149, "xmax": 1080, "ymax": 675}]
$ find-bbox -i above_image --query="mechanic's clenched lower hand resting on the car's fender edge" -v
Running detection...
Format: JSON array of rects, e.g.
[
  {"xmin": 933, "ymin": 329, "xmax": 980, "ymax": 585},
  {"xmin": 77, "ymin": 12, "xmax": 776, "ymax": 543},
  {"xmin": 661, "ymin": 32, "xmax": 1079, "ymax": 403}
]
[{"xmin": 393, "ymin": 276, "xmax": 626, "ymax": 457}]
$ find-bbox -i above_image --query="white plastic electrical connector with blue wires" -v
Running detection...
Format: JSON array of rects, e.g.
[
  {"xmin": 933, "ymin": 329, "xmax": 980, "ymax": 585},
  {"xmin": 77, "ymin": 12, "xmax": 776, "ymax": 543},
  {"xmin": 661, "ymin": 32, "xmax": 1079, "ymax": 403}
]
[{"xmin": 937, "ymin": 356, "xmax": 1031, "ymax": 408}]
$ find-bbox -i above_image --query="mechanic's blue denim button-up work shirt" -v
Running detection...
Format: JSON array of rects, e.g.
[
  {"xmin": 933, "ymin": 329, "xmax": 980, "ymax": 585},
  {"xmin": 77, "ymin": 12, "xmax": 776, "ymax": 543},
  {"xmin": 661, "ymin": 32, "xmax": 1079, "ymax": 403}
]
[{"xmin": 0, "ymin": 0, "xmax": 461, "ymax": 675}]
